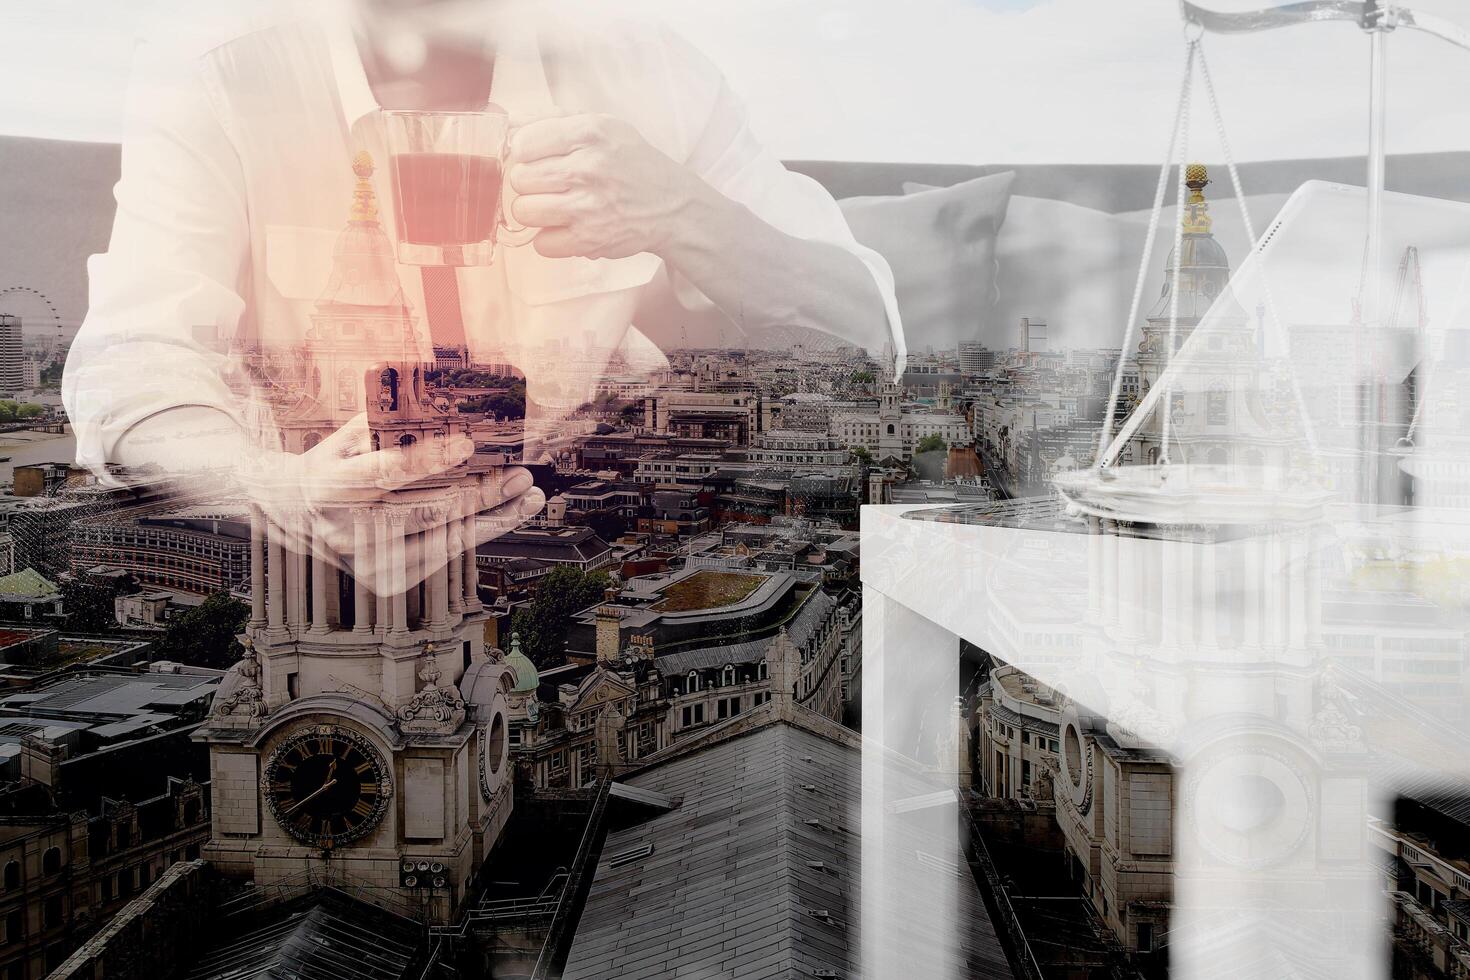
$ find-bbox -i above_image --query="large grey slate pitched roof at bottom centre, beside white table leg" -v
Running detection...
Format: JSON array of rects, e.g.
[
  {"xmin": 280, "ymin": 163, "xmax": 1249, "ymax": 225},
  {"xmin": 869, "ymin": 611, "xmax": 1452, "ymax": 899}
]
[{"xmin": 563, "ymin": 713, "xmax": 1011, "ymax": 980}]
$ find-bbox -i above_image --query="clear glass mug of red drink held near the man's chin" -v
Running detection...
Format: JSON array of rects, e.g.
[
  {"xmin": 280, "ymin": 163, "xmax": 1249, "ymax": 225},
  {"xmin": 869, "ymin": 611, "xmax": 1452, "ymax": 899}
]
[{"xmin": 382, "ymin": 106, "xmax": 539, "ymax": 266}]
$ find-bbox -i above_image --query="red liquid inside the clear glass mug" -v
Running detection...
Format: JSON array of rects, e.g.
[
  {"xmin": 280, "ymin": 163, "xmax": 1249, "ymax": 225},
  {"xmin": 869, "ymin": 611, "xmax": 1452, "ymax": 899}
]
[{"xmin": 390, "ymin": 153, "xmax": 500, "ymax": 245}]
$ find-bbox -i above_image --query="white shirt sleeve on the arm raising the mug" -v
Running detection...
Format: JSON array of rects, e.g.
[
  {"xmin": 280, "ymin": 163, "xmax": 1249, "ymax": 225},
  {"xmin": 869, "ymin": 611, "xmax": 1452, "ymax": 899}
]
[{"xmin": 666, "ymin": 25, "xmax": 907, "ymax": 376}]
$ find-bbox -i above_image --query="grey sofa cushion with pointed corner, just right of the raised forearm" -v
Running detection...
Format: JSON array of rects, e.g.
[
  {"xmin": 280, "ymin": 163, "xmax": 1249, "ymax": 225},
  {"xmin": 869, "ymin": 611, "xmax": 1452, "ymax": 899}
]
[{"xmin": 838, "ymin": 170, "xmax": 1016, "ymax": 351}]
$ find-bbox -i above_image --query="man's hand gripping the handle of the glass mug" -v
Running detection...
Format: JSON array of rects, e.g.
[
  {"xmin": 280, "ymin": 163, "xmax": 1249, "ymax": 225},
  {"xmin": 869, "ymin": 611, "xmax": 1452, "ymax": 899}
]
[{"xmin": 506, "ymin": 115, "xmax": 714, "ymax": 259}]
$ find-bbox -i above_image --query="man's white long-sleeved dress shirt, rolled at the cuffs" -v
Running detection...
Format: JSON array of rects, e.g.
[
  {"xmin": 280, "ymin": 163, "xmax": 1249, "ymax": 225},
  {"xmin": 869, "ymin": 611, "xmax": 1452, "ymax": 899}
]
[{"xmin": 62, "ymin": 3, "xmax": 903, "ymax": 475}]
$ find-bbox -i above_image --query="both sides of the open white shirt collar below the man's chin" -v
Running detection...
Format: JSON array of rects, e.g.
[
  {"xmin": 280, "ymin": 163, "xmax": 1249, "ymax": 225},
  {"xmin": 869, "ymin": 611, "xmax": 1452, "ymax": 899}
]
[{"xmin": 319, "ymin": 0, "xmax": 556, "ymax": 129}]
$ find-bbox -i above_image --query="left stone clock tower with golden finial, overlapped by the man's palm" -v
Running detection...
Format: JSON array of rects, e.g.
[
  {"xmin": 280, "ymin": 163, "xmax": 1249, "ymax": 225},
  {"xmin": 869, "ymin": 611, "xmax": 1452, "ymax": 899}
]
[{"xmin": 197, "ymin": 153, "xmax": 516, "ymax": 921}]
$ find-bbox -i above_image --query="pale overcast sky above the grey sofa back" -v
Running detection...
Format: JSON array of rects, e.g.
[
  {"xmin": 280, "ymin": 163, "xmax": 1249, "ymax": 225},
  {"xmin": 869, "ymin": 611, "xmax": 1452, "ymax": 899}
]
[{"xmin": 0, "ymin": 0, "xmax": 1470, "ymax": 163}]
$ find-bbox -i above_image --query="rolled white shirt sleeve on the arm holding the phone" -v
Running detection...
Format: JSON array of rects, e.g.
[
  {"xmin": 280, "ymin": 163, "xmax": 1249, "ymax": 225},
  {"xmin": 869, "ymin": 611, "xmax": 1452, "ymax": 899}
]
[{"xmin": 62, "ymin": 34, "xmax": 248, "ymax": 483}]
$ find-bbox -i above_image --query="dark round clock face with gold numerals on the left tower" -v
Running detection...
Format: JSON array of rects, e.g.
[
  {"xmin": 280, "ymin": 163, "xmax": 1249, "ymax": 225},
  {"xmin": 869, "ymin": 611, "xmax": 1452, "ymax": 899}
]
[{"xmin": 265, "ymin": 724, "xmax": 390, "ymax": 848}]
